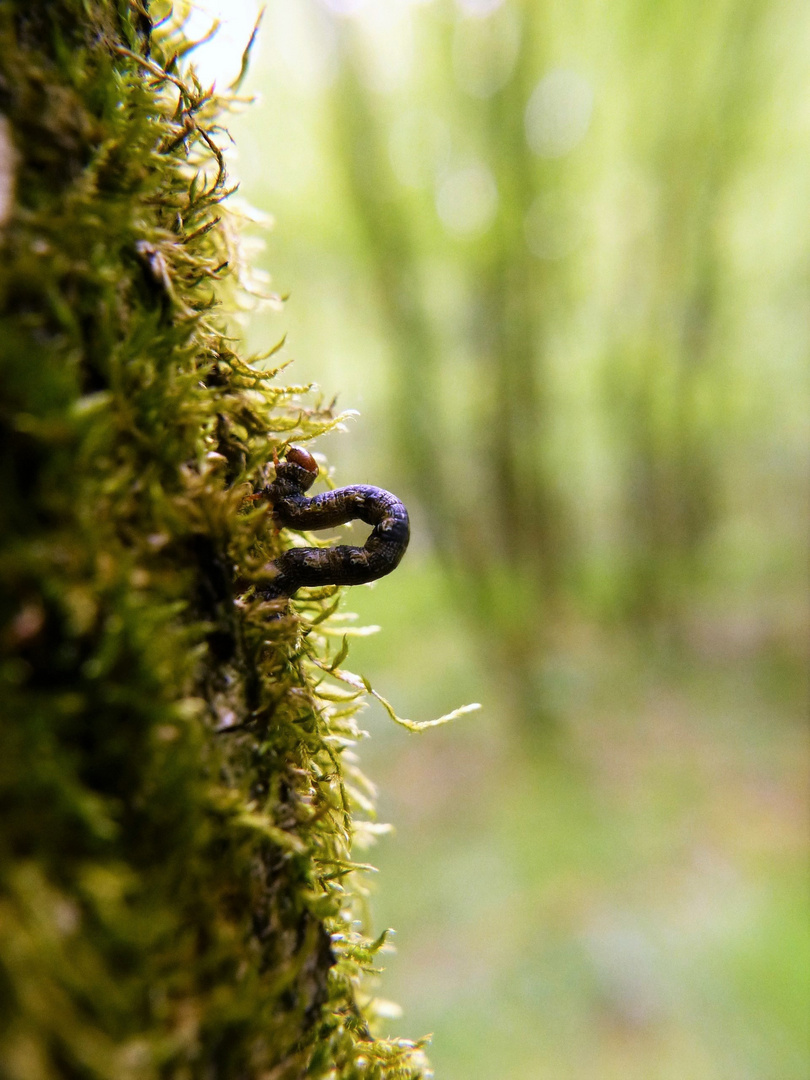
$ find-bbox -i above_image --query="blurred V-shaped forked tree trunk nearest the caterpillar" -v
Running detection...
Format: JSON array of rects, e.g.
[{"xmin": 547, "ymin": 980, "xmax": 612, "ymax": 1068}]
[{"xmin": 334, "ymin": 6, "xmax": 568, "ymax": 718}]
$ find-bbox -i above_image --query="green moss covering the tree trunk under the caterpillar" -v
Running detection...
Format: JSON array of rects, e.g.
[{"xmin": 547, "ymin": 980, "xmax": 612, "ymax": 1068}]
[{"xmin": 0, "ymin": 0, "xmax": 430, "ymax": 1080}]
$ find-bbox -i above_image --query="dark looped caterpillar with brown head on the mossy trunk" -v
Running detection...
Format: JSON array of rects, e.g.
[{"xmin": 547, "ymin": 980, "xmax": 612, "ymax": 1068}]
[{"xmin": 255, "ymin": 446, "xmax": 410, "ymax": 599}]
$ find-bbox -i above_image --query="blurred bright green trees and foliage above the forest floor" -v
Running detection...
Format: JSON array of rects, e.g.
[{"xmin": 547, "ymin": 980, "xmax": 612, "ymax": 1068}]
[{"xmin": 242, "ymin": 0, "xmax": 810, "ymax": 724}]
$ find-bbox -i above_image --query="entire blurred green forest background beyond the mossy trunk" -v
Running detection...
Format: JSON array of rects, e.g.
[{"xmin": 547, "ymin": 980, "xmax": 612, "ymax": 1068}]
[{"xmin": 189, "ymin": 0, "xmax": 810, "ymax": 1080}]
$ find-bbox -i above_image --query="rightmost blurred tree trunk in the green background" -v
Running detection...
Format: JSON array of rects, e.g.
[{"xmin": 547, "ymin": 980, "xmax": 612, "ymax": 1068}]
[{"xmin": 605, "ymin": 0, "xmax": 766, "ymax": 633}]
